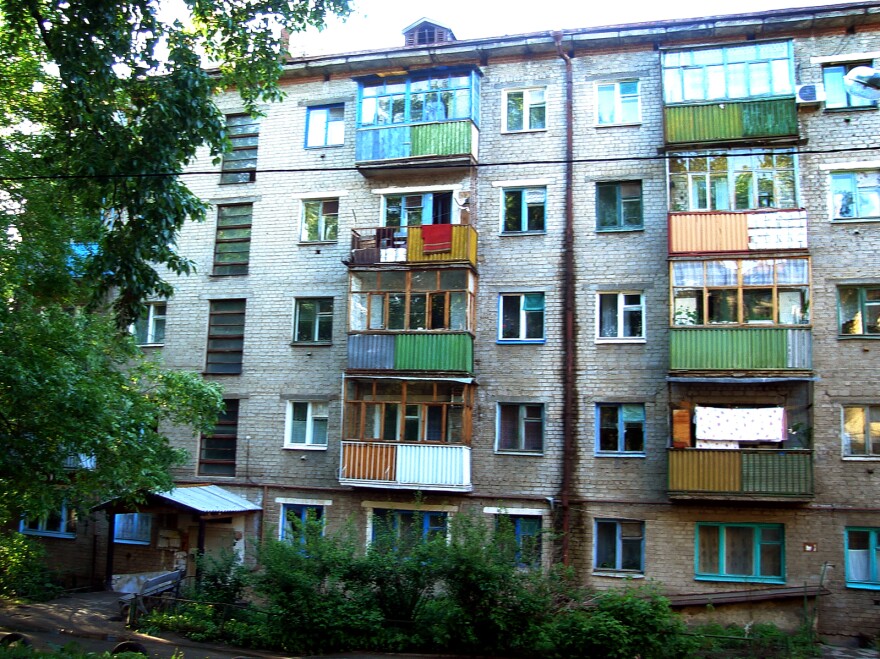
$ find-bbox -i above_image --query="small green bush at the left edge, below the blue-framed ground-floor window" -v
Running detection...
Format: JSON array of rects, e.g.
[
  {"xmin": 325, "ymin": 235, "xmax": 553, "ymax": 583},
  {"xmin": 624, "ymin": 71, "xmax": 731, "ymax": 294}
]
[{"xmin": 0, "ymin": 531, "xmax": 60, "ymax": 600}]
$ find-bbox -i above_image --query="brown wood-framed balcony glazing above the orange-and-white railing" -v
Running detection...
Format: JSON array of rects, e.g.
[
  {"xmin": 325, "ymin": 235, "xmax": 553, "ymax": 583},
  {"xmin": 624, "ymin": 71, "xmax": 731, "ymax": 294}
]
[{"xmin": 343, "ymin": 379, "xmax": 473, "ymax": 444}]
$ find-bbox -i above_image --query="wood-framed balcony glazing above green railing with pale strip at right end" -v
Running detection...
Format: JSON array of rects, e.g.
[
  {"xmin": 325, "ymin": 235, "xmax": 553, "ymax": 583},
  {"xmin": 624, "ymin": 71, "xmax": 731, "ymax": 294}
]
[{"xmin": 672, "ymin": 259, "xmax": 810, "ymax": 326}]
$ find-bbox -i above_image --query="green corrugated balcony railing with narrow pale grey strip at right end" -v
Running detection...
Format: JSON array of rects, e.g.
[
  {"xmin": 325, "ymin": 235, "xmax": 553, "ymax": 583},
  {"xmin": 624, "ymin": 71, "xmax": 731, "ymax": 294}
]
[{"xmin": 669, "ymin": 327, "xmax": 813, "ymax": 371}]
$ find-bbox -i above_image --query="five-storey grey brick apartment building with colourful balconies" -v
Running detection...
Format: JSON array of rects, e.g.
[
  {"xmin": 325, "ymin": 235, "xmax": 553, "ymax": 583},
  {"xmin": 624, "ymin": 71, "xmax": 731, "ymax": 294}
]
[{"xmin": 27, "ymin": 2, "xmax": 880, "ymax": 636}]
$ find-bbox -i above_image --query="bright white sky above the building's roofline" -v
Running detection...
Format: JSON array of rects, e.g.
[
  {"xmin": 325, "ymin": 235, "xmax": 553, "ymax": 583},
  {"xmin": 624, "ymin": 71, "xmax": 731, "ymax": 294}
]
[{"xmin": 291, "ymin": 0, "xmax": 860, "ymax": 55}]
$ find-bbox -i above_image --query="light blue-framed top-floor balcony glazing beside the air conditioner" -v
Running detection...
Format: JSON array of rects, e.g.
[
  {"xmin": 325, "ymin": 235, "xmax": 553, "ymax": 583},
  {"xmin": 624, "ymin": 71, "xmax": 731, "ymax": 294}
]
[{"xmin": 663, "ymin": 41, "xmax": 794, "ymax": 103}]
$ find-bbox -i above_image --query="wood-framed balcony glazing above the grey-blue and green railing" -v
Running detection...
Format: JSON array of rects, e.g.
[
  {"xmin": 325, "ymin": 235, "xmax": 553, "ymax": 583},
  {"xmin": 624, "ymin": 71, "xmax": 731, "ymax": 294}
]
[{"xmin": 349, "ymin": 269, "xmax": 476, "ymax": 332}]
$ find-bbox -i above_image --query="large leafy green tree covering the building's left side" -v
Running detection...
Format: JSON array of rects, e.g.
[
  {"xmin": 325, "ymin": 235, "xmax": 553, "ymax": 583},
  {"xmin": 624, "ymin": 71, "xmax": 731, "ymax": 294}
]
[{"xmin": 0, "ymin": 0, "xmax": 348, "ymax": 521}]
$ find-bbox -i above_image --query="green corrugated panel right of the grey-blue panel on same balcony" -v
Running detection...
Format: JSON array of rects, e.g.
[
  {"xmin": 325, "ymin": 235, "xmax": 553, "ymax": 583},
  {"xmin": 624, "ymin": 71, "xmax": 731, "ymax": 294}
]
[{"xmin": 394, "ymin": 332, "xmax": 474, "ymax": 373}]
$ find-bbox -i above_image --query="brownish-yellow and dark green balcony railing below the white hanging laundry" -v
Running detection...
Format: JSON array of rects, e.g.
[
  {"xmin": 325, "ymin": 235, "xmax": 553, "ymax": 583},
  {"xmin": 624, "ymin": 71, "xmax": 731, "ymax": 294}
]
[{"xmin": 668, "ymin": 448, "xmax": 813, "ymax": 499}]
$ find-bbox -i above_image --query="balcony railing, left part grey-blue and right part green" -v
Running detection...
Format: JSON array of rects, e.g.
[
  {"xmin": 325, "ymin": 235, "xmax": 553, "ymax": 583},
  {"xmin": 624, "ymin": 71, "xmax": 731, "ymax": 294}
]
[{"xmin": 348, "ymin": 332, "xmax": 474, "ymax": 373}]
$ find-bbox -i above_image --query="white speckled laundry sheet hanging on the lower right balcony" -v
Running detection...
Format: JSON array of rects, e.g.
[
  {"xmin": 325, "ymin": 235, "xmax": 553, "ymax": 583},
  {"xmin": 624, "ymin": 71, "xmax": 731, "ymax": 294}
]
[{"xmin": 694, "ymin": 407, "xmax": 788, "ymax": 442}]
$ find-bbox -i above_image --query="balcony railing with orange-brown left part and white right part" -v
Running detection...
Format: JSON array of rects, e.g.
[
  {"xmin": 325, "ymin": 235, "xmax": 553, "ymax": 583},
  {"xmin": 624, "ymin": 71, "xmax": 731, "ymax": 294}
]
[{"xmin": 339, "ymin": 441, "xmax": 471, "ymax": 492}]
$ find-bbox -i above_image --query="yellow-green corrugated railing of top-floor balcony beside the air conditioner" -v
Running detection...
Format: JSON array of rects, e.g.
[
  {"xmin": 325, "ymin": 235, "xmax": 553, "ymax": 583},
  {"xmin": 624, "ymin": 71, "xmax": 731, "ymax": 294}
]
[{"xmin": 664, "ymin": 96, "xmax": 798, "ymax": 145}]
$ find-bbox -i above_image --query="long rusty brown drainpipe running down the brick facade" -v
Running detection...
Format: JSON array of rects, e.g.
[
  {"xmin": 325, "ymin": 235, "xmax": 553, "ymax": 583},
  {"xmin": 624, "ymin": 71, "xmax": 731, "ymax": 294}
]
[{"xmin": 552, "ymin": 32, "xmax": 577, "ymax": 565}]
